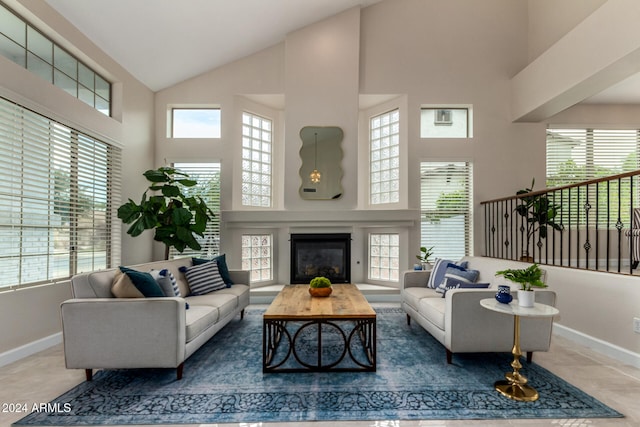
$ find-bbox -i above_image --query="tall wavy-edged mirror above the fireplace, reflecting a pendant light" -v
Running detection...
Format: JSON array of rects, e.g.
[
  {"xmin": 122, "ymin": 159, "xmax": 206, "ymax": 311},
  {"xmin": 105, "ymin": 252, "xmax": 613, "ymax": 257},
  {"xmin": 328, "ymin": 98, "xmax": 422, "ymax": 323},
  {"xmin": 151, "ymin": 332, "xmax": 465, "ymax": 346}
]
[{"xmin": 300, "ymin": 126, "xmax": 343, "ymax": 200}]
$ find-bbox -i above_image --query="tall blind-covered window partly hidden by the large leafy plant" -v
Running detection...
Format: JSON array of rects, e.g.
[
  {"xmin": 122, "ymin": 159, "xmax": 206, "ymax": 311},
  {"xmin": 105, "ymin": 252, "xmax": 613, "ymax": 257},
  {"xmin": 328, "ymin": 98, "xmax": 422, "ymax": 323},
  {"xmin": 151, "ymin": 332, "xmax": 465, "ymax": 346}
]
[{"xmin": 169, "ymin": 162, "xmax": 220, "ymax": 259}]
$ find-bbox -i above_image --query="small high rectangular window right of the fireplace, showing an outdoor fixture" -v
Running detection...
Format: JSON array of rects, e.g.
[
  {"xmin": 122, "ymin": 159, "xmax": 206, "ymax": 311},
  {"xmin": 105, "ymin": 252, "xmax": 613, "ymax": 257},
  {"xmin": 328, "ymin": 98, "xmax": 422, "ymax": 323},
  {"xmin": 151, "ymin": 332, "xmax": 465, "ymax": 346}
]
[{"xmin": 420, "ymin": 107, "xmax": 471, "ymax": 138}]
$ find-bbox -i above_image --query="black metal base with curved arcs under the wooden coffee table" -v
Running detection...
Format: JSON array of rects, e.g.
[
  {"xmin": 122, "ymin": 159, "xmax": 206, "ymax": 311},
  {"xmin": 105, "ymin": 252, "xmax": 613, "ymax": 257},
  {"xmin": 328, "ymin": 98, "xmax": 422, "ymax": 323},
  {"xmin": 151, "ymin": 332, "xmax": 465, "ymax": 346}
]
[{"xmin": 262, "ymin": 318, "xmax": 376, "ymax": 372}]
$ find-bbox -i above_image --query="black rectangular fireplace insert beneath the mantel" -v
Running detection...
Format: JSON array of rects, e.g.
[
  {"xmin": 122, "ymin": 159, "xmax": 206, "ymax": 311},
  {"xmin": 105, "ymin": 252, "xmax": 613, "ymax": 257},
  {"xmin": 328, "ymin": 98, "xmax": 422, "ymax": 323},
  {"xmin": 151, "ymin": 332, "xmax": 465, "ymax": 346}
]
[{"xmin": 290, "ymin": 233, "xmax": 351, "ymax": 284}]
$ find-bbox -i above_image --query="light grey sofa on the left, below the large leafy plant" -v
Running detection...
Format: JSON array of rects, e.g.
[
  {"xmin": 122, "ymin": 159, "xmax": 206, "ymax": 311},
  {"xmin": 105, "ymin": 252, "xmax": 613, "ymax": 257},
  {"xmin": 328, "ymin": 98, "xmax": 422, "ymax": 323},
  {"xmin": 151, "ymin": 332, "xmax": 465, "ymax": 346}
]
[{"xmin": 61, "ymin": 258, "xmax": 249, "ymax": 381}]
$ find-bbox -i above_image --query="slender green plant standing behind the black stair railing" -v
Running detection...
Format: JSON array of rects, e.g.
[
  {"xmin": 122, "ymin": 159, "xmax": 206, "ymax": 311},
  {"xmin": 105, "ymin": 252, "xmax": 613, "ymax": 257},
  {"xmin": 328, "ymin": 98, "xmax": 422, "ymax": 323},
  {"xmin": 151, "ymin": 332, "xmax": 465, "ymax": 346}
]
[{"xmin": 515, "ymin": 178, "xmax": 564, "ymax": 262}]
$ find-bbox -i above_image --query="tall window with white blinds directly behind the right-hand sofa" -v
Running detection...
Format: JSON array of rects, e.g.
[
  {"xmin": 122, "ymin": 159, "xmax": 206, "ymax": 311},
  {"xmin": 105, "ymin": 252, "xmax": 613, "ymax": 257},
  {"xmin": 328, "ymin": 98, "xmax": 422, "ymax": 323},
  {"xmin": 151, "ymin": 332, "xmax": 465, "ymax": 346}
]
[{"xmin": 420, "ymin": 162, "xmax": 473, "ymax": 259}]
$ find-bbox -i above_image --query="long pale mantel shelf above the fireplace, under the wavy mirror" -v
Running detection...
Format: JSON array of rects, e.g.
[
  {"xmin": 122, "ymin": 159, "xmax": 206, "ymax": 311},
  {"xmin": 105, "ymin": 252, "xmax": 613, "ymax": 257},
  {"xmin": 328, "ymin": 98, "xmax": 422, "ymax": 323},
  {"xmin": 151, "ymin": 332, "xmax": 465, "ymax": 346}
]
[{"xmin": 221, "ymin": 209, "xmax": 420, "ymax": 228}]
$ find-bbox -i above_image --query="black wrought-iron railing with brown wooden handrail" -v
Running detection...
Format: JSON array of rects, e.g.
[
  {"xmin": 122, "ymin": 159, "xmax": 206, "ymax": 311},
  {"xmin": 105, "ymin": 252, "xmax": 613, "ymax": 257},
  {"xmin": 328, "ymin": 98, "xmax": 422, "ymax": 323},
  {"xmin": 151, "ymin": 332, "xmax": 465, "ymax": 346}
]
[{"xmin": 481, "ymin": 170, "xmax": 640, "ymax": 274}]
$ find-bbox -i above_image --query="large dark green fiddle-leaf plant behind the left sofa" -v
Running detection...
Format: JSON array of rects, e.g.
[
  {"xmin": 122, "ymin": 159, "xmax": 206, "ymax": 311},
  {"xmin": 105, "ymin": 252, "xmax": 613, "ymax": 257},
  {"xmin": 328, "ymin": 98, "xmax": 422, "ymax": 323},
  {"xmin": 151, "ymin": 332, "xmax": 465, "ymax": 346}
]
[{"xmin": 118, "ymin": 167, "xmax": 214, "ymax": 252}]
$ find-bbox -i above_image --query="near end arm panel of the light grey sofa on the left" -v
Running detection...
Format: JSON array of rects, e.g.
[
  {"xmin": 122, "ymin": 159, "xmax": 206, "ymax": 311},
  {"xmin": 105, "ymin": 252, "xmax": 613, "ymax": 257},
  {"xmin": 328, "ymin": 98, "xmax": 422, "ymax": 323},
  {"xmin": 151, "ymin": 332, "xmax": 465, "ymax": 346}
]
[{"xmin": 60, "ymin": 297, "xmax": 186, "ymax": 369}]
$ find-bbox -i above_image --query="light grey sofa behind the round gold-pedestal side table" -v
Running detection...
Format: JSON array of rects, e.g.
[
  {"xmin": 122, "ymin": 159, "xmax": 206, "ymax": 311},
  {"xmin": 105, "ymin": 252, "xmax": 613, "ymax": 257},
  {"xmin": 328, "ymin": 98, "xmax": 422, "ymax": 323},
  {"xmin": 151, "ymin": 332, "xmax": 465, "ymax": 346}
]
[{"xmin": 401, "ymin": 257, "xmax": 556, "ymax": 363}]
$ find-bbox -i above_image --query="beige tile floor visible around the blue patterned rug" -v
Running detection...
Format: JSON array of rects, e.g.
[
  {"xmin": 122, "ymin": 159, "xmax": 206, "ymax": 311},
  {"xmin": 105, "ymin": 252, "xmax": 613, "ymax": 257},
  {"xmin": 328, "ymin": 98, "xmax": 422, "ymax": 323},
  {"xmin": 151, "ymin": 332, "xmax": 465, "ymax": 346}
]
[{"xmin": 0, "ymin": 306, "xmax": 640, "ymax": 427}]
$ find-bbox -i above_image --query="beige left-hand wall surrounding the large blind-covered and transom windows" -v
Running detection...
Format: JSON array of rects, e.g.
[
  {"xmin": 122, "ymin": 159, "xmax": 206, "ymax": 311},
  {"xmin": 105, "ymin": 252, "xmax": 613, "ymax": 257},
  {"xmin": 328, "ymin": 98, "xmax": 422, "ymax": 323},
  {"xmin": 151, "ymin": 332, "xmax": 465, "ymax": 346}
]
[{"xmin": 0, "ymin": 0, "xmax": 154, "ymax": 361}]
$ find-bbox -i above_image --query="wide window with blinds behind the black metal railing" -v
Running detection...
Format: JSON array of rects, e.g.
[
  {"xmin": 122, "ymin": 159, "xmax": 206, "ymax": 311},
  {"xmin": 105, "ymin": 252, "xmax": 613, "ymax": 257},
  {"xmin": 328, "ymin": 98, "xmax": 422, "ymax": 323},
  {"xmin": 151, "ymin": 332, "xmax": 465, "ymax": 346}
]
[{"xmin": 546, "ymin": 129, "xmax": 640, "ymax": 226}]
